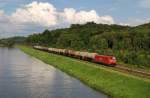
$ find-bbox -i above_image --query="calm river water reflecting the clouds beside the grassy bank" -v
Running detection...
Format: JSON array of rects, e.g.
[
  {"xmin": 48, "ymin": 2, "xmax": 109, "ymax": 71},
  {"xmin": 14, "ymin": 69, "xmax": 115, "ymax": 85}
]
[{"xmin": 0, "ymin": 48, "xmax": 107, "ymax": 98}]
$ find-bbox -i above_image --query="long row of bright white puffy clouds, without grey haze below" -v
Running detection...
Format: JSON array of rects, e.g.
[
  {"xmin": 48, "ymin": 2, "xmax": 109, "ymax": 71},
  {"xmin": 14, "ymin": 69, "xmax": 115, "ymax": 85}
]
[{"xmin": 11, "ymin": 2, "xmax": 114, "ymax": 27}]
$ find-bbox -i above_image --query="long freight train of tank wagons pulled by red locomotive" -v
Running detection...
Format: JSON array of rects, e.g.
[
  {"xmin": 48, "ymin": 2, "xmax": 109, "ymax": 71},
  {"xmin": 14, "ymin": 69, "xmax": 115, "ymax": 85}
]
[{"xmin": 33, "ymin": 46, "xmax": 117, "ymax": 66}]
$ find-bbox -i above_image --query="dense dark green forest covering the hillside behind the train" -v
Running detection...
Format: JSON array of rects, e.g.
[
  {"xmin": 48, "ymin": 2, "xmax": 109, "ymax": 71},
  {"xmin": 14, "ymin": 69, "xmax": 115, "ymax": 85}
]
[{"xmin": 26, "ymin": 22, "xmax": 150, "ymax": 68}]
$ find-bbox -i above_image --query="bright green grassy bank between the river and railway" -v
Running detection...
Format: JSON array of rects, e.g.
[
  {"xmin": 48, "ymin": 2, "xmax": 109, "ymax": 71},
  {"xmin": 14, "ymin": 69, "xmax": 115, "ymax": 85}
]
[{"xmin": 17, "ymin": 46, "xmax": 150, "ymax": 98}]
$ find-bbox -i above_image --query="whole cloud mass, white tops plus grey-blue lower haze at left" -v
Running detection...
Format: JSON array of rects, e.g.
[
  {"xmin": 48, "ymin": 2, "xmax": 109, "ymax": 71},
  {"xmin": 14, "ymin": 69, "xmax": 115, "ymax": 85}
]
[{"xmin": 0, "ymin": 1, "xmax": 115, "ymax": 36}]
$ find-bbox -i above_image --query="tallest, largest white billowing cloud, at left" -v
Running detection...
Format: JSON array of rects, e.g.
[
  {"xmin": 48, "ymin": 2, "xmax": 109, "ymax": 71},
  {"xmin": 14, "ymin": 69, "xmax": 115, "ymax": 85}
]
[{"xmin": 12, "ymin": 2, "xmax": 57, "ymax": 26}]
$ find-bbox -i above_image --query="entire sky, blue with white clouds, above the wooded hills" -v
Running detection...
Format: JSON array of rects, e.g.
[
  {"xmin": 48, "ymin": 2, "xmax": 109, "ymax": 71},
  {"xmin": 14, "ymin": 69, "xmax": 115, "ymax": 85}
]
[{"xmin": 0, "ymin": 0, "xmax": 150, "ymax": 38}]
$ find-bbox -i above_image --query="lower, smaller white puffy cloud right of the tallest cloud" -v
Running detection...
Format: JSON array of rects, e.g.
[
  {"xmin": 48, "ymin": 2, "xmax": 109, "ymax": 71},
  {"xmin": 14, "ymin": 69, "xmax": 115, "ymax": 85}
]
[{"xmin": 62, "ymin": 8, "xmax": 114, "ymax": 24}]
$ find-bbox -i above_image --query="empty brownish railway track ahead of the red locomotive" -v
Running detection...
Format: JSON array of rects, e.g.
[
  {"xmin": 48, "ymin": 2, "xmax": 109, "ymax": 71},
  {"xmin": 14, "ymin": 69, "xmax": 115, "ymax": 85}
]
[{"xmin": 115, "ymin": 65, "xmax": 150, "ymax": 77}]
